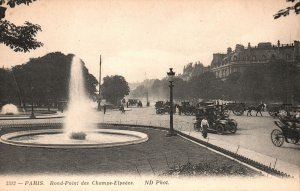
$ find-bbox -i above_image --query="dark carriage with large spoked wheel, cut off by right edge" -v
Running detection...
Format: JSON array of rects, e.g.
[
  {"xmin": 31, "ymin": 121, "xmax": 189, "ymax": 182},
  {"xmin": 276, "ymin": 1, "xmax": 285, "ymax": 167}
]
[{"xmin": 271, "ymin": 117, "xmax": 300, "ymax": 147}]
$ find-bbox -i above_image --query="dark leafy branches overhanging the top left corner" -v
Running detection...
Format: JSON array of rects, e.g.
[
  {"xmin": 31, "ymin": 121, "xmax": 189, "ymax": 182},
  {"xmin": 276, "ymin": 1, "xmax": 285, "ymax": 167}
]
[{"xmin": 0, "ymin": 0, "xmax": 43, "ymax": 52}]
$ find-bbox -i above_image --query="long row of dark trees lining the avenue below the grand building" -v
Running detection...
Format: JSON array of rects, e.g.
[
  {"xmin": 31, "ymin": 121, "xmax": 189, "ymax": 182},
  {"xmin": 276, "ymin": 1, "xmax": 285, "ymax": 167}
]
[{"xmin": 134, "ymin": 60, "xmax": 300, "ymax": 102}]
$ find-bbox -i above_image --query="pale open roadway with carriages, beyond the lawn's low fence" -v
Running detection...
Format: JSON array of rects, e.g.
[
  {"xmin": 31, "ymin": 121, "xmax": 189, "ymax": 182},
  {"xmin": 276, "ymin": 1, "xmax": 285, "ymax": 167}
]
[{"xmin": 100, "ymin": 107, "xmax": 300, "ymax": 176}]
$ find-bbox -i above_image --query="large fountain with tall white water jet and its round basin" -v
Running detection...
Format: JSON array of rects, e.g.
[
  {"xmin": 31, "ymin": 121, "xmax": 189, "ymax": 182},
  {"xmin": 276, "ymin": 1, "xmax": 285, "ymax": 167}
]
[{"xmin": 0, "ymin": 57, "xmax": 148, "ymax": 148}]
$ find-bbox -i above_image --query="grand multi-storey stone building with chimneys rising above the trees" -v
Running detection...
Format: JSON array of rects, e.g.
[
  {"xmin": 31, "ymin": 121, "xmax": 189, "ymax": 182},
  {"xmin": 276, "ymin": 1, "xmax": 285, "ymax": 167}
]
[{"xmin": 210, "ymin": 41, "xmax": 300, "ymax": 79}]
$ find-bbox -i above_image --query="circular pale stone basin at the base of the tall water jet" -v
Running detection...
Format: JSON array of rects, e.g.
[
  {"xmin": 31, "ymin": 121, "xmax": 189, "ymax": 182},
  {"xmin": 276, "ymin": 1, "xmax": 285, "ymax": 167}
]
[{"xmin": 0, "ymin": 129, "xmax": 148, "ymax": 148}]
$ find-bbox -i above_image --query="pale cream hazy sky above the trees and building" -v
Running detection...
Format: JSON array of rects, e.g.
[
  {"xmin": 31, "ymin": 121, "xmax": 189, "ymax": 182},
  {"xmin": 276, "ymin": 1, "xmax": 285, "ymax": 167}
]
[{"xmin": 0, "ymin": 0, "xmax": 300, "ymax": 82}]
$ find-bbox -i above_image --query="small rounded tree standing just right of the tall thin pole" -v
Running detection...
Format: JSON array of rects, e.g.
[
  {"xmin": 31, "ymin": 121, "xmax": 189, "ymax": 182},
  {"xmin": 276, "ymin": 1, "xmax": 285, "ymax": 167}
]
[{"xmin": 101, "ymin": 75, "xmax": 129, "ymax": 105}]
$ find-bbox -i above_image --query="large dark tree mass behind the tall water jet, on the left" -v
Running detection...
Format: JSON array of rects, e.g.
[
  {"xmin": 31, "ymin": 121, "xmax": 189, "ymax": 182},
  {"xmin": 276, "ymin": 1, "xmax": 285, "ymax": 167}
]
[{"xmin": 0, "ymin": 52, "xmax": 98, "ymax": 105}]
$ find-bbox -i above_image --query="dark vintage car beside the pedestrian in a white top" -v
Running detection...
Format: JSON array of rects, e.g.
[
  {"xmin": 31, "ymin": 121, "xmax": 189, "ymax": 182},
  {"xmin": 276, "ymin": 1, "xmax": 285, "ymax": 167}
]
[{"xmin": 194, "ymin": 106, "xmax": 237, "ymax": 135}]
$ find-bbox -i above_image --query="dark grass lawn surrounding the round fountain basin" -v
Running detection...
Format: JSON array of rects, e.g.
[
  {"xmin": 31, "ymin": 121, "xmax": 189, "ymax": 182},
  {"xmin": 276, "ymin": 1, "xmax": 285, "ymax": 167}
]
[{"xmin": 0, "ymin": 124, "xmax": 259, "ymax": 176}]
